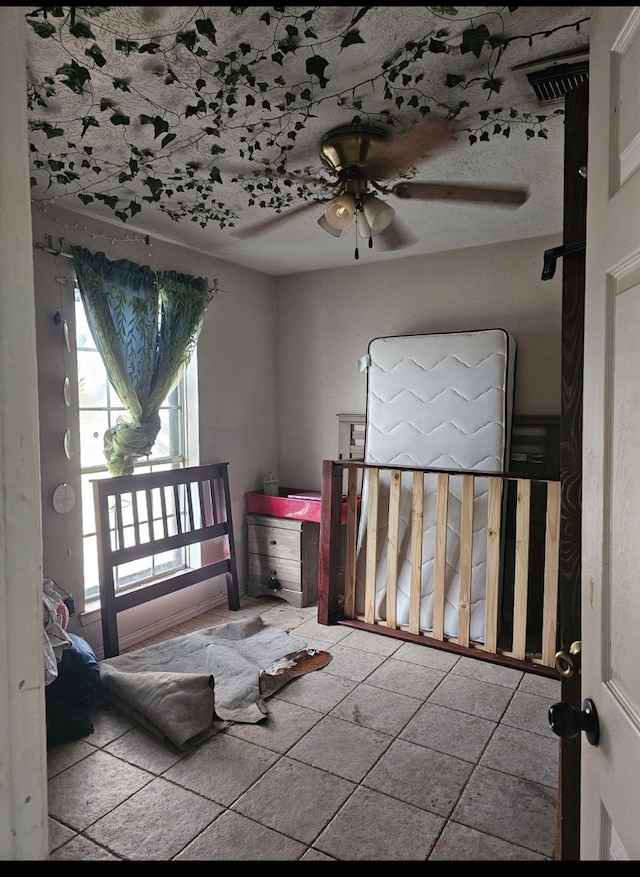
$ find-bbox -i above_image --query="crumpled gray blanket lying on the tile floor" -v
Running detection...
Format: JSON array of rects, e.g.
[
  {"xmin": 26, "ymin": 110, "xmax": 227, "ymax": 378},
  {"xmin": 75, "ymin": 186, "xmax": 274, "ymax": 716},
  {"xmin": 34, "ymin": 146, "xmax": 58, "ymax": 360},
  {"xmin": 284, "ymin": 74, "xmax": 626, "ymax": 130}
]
[{"xmin": 100, "ymin": 616, "xmax": 318, "ymax": 749}]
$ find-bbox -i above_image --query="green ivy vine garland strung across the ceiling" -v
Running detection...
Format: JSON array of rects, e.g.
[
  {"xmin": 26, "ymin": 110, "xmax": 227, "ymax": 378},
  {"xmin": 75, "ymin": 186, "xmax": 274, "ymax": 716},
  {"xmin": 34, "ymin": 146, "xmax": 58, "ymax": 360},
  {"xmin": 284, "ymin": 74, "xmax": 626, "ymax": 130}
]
[{"xmin": 26, "ymin": 6, "xmax": 588, "ymax": 228}]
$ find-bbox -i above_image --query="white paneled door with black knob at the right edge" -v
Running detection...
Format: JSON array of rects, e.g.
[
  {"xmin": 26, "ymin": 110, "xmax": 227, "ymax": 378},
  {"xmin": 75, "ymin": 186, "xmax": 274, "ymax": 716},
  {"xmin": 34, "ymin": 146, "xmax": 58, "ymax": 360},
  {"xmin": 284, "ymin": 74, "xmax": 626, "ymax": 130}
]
[{"xmin": 580, "ymin": 6, "xmax": 640, "ymax": 860}]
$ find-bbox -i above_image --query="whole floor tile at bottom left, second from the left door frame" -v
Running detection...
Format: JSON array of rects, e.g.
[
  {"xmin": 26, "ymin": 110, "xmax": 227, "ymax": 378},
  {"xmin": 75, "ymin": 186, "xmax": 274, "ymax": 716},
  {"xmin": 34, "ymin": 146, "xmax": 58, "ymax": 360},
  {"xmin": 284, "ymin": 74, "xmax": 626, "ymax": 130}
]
[{"xmin": 86, "ymin": 778, "xmax": 223, "ymax": 862}]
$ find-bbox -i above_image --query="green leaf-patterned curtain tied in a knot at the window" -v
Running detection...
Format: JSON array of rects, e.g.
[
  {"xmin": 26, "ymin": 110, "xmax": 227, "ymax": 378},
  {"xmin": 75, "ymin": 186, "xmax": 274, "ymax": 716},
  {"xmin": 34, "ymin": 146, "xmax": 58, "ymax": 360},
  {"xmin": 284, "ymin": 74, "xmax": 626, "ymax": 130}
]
[{"xmin": 71, "ymin": 247, "xmax": 211, "ymax": 475}]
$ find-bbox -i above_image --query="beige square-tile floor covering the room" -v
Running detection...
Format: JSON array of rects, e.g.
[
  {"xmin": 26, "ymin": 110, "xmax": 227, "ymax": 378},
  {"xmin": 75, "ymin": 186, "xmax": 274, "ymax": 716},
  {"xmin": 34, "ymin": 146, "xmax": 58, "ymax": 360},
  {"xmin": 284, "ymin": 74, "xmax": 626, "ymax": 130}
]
[{"xmin": 48, "ymin": 597, "xmax": 560, "ymax": 861}]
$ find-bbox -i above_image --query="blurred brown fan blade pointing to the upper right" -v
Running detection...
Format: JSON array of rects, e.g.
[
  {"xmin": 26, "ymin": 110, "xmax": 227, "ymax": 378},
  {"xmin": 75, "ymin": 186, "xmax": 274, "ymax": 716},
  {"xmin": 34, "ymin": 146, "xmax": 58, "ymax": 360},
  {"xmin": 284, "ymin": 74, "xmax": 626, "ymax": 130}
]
[{"xmin": 366, "ymin": 116, "xmax": 456, "ymax": 180}]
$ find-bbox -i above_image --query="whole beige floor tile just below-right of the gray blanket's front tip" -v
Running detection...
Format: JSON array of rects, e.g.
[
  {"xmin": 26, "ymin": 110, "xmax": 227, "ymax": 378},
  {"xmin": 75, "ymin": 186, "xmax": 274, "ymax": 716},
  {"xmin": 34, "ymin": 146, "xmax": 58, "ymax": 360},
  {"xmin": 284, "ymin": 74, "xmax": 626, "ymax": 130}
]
[{"xmin": 164, "ymin": 734, "xmax": 278, "ymax": 806}]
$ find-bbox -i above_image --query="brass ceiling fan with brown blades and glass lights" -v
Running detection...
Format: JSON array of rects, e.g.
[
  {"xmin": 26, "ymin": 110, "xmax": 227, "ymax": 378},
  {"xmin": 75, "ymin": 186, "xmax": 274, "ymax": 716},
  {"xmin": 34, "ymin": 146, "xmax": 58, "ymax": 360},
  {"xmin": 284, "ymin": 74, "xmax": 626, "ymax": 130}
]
[{"xmin": 235, "ymin": 116, "xmax": 529, "ymax": 259}]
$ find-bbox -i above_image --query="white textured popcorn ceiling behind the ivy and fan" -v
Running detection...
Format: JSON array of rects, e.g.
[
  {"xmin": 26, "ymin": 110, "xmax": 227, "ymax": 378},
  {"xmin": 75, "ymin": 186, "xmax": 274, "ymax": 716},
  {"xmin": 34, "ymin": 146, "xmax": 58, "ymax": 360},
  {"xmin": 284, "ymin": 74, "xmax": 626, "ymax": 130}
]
[{"xmin": 24, "ymin": 6, "xmax": 591, "ymax": 276}]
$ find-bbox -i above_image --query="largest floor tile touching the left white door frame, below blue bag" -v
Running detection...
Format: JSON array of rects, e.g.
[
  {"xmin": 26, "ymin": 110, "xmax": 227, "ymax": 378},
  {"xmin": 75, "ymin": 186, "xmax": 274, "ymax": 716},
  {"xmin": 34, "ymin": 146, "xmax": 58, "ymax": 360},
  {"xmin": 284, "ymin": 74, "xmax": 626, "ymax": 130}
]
[{"xmin": 48, "ymin": 752, "xmax": 153, "ymax": 831}]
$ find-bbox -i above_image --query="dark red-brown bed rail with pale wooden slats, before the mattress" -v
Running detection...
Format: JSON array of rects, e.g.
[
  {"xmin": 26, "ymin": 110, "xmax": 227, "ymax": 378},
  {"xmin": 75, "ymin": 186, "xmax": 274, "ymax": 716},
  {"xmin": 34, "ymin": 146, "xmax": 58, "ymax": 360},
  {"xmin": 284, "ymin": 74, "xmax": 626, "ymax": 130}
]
[{"xmin": 318, "ymin": 460, "xmax": 561, "ymax": 675}]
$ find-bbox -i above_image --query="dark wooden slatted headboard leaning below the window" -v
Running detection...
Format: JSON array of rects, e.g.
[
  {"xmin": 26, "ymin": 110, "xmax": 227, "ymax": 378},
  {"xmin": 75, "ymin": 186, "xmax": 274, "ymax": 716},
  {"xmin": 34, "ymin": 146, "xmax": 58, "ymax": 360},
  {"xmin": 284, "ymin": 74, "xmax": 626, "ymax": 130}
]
[{"xmin": 93, "ymin": 463, "xmax": 240, "ymax": 658}]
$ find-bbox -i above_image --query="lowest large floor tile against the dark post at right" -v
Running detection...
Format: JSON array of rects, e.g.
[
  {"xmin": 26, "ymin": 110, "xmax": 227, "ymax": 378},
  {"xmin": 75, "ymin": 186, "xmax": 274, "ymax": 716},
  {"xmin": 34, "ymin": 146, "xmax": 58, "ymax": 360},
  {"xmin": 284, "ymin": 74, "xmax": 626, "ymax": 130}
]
[{"xmin": 451, "ymin": 765, "xmax": 557, "ymax": 858}]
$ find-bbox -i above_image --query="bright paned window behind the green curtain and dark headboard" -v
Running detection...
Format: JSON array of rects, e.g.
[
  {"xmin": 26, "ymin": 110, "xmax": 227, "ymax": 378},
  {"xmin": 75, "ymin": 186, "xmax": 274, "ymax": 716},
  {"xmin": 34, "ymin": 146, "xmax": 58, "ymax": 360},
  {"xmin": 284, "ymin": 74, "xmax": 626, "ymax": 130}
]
[{"xmin": 75, "ymin": 287, "xmax": 191, "ymax": 605}]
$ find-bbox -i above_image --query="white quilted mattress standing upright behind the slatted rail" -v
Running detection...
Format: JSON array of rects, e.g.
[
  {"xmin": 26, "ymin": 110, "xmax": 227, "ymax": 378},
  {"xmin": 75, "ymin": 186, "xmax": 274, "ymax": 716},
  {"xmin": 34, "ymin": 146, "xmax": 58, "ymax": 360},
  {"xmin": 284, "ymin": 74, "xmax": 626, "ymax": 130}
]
[{"xmin": 356, "ymin": 329, "xmax": 516, "ymax": 642}]
